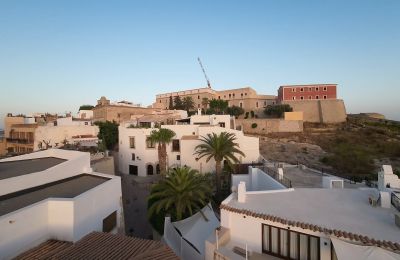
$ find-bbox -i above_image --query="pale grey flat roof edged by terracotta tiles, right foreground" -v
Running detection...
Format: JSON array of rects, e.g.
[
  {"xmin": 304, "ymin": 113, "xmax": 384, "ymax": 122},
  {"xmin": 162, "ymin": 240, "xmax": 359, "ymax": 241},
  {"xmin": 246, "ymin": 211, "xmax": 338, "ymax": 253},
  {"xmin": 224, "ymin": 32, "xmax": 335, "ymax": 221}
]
[{"xmin": 225, "ymin": 188, "xmax": 400, "ymax": 243}]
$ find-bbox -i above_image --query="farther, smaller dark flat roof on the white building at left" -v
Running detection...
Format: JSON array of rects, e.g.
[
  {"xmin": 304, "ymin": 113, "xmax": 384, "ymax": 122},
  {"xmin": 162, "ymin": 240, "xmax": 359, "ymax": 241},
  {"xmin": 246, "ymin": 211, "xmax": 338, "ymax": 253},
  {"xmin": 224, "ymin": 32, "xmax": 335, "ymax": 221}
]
[{"xmin": 0, "ymin": 157, "xmax": 66, "ymax": 180}]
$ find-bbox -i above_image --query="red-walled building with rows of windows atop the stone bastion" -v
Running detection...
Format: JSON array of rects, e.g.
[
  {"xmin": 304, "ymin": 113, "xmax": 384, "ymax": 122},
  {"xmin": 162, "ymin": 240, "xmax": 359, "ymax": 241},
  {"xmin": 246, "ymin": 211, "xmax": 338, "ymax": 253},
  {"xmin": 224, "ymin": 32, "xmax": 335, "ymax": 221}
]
[{"xmin": 278, "ymin": 84, "xmax": 337, "ymax": 102}]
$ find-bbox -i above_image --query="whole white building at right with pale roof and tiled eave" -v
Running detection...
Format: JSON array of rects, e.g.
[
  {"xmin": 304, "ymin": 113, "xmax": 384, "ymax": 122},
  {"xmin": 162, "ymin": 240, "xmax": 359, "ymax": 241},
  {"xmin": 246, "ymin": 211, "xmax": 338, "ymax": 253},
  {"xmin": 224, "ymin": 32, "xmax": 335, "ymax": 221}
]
[{"xmin": 206, "ymin": 167, "xmax": 400, "ymax": 260}]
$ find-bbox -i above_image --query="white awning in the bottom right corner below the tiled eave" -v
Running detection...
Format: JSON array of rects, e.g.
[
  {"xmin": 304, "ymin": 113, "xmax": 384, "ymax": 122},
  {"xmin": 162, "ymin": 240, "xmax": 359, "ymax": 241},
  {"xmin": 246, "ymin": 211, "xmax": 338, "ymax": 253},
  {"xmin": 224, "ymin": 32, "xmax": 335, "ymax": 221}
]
[{"xmin": 331, "ymin": 238, "xmax": 400, "ymax": 260}]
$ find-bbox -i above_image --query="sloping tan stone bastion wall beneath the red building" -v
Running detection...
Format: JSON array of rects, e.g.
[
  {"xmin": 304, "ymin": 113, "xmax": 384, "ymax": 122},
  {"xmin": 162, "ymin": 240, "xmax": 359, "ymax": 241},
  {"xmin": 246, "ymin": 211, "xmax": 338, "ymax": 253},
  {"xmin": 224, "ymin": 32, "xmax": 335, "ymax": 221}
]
[{"xmin": 283, "ymin": 99, "xmax": 347, "ymax": 124}]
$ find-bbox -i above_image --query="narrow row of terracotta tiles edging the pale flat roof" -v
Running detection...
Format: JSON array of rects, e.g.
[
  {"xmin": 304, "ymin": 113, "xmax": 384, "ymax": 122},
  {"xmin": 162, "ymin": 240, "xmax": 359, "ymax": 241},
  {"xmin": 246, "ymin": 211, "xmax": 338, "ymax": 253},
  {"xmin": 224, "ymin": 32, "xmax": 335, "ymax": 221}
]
[{"xmin": 220, "ymin": 204, "xmax": 400, "ymax": 252}]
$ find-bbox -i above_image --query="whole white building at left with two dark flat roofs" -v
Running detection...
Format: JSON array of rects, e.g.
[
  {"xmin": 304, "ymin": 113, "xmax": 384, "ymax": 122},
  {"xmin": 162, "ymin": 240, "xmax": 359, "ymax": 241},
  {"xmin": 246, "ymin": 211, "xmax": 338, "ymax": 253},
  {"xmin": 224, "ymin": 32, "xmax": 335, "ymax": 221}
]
[{"xmin": 0, "ymin": 149, "xmax": 122, "ymax": 259}]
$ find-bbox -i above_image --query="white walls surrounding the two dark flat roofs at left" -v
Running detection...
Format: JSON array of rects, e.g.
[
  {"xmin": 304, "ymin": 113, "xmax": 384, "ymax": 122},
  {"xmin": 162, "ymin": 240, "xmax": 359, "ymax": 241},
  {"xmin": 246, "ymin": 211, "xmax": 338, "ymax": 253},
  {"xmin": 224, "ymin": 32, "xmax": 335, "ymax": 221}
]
[{"xmin": 0, "ymin": 149, "xmax": 122, "ymax": 259}]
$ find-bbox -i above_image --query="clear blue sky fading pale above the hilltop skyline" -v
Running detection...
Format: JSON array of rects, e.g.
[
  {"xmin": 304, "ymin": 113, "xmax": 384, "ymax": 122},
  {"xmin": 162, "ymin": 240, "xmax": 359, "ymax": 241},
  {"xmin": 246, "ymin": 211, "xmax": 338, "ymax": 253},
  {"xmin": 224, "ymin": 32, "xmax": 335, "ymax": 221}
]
[{"xmin": 0, "ymin": 0, "xmax": 400, "ymax": 128}]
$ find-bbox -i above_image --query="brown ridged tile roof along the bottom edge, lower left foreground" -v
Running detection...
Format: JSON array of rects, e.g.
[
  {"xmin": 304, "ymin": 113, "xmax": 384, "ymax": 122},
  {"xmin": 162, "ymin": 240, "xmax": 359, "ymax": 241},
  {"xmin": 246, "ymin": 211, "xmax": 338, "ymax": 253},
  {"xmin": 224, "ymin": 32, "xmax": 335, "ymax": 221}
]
[{"xmin": 12, "ymin": 232, "xmax": 179, "ymax": 260}]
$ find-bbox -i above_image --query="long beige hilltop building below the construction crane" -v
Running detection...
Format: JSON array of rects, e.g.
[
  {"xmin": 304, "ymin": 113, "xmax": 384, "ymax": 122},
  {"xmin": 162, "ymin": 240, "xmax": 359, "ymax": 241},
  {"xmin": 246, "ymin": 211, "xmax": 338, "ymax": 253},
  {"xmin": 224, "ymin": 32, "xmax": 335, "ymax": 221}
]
[{"xmin": 153, "ymin": 87, "xmax": 276, "ymax": 111}]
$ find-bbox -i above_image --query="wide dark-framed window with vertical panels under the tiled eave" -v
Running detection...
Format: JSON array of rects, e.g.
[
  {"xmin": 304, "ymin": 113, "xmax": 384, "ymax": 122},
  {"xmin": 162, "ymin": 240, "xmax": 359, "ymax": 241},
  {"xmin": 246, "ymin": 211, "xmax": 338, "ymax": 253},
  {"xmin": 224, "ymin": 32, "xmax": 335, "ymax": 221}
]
[{"xmin": 262, "ymin": 224, "xmax": 320, "ymax": 260}]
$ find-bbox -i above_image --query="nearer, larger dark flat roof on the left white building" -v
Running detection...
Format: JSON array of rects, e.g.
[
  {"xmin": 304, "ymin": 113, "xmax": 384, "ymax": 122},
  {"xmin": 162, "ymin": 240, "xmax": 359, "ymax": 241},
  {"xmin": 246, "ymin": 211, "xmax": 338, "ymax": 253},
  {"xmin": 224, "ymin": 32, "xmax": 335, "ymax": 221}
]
[{"xmin": 0, "ymin": 174, "xmax": 109, "ymax": 216}]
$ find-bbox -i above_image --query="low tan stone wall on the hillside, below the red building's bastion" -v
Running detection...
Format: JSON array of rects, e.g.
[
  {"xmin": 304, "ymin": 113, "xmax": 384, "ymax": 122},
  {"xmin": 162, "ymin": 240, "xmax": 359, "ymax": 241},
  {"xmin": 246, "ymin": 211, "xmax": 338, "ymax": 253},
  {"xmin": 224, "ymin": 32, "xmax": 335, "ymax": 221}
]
[{"xmin": 236, "ymin": 118, "xmax": 303, "ymax": 134}]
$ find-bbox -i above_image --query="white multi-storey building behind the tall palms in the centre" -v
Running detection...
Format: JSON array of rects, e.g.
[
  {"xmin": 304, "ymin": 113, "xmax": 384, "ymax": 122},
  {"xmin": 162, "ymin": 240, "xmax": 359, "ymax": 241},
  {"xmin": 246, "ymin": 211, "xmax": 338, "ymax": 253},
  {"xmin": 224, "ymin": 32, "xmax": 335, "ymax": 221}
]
[{"xmin": 119, "ymin": 115, "xmax": 260, "ymax": 176}]
